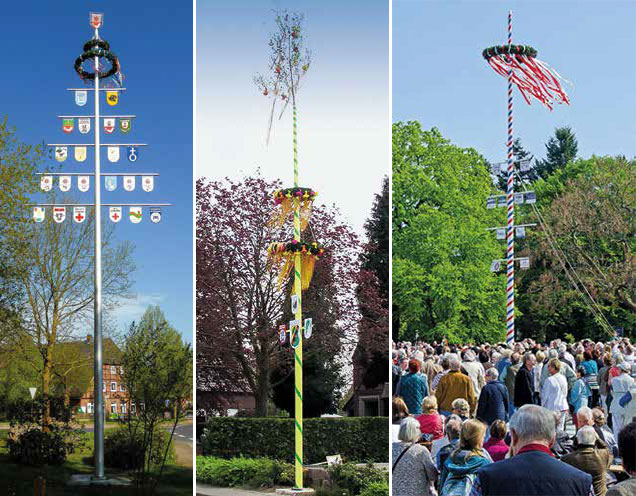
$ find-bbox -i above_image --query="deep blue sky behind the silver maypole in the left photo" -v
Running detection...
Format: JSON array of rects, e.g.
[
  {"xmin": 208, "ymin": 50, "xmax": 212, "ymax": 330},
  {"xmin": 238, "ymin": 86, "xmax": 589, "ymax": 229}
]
[{"xmin": 0, "ymin": 0, "xmax": 193, "ymax": 342}]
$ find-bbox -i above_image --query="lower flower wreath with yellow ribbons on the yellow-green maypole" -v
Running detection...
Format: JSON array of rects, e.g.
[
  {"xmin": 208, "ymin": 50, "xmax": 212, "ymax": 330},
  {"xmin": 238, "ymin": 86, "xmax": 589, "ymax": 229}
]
[{"xmin": 267, "ymin": 241, "xmax": 325, "ymax": 293}]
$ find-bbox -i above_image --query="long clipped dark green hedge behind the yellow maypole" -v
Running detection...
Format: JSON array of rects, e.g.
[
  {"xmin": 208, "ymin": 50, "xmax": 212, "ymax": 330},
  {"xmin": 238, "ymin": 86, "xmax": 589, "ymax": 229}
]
[{"xmin": 201, "ymin": 417, "xmax": 389, "ymax": 464}]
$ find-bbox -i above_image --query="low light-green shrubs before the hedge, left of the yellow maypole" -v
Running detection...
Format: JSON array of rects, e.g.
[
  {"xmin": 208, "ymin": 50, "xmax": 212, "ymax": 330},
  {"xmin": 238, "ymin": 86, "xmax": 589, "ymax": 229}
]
[{"xmin": 197, "ymin": 456, "xmax": 294, "ymax": 487}]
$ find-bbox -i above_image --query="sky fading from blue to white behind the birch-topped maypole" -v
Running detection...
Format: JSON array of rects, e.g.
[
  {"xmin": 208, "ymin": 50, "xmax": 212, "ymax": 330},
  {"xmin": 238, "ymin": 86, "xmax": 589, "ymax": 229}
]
[{"xmin": 196, "ymin": 0, "xmax": 391, "ymax": 232}]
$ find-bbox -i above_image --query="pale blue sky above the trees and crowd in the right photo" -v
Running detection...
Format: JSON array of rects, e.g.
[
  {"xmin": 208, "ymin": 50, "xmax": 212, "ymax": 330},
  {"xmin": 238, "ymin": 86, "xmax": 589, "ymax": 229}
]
[{"xmin": 393, "ymin": 0, "xmax": 636, "ymax": 162}]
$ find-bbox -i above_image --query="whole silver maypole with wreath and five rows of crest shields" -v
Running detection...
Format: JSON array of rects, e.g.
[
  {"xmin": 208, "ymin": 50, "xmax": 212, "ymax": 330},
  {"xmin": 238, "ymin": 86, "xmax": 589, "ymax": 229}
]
[{"xmin": 33, "ymin": 12, "xmax": 171, "ymax": 485}]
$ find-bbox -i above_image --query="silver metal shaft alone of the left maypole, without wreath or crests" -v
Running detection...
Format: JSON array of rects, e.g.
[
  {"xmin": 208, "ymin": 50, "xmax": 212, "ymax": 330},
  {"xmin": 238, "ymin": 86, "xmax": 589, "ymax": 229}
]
[{"xmin": 93, "ymin": 28, "xmax": 105, "ymax": 479}]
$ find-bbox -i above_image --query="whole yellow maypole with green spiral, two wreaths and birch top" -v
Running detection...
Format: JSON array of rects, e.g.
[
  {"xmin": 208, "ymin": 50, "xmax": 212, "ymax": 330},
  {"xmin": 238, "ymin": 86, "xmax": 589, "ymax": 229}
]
[{"xmin": 254, "ymin": 12, "xmax": 323, "ymax": 494}]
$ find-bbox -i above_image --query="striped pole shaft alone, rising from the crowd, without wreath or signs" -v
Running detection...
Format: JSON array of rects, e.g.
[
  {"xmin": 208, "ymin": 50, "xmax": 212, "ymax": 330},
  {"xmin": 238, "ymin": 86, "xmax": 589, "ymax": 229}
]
[{"xmin": 506, "ymin": 10, "xmax": 515, "ymax": 344}]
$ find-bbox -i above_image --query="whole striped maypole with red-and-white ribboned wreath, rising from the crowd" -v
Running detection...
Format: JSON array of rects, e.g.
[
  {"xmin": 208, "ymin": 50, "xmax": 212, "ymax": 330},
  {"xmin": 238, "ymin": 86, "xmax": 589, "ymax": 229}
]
[{"xmin": 482, "ymin": 10, "xmax": 570, "ymax": 344}]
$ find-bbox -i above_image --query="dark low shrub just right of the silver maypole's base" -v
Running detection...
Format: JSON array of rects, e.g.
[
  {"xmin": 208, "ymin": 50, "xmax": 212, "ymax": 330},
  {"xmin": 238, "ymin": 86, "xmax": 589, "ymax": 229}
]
[{"xmin": 104, "ymin": 425, "xmax": 176, "ymax": 470}]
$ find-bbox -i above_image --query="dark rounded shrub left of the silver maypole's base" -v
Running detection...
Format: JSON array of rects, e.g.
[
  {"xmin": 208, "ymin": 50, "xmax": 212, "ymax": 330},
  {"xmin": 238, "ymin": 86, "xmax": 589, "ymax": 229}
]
[{"xmin": 7, "ymin": 428, "xmax": 70, "ymax": 467}]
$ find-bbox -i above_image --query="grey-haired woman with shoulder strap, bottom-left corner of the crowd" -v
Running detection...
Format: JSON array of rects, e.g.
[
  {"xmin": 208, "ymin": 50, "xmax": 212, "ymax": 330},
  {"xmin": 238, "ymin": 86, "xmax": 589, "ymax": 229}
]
[{"xmin": 391, "ymin": 417, "xmax": 438, "ymax": 496}]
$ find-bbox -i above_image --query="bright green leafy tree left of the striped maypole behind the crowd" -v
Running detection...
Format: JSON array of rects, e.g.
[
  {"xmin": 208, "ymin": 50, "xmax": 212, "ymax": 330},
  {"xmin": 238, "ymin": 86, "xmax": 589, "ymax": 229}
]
[{"xmin": 392, "ymin": 122, "xmax": 505, "ymax": 342}]
